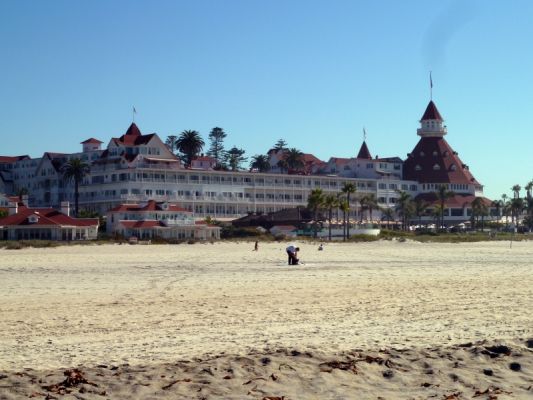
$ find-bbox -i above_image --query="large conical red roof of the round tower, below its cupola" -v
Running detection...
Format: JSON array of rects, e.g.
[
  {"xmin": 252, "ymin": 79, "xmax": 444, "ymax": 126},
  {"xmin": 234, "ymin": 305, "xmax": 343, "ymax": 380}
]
[{"xmin": 403, "ymin": 137, "xmax": 479, "ymax": 185}]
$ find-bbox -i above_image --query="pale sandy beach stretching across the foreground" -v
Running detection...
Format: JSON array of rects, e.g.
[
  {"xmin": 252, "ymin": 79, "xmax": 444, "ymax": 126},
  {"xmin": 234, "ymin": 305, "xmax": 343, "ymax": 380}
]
[{"xmin": 0, "ymin": 241, "xmax": 533, "ymax": 400}]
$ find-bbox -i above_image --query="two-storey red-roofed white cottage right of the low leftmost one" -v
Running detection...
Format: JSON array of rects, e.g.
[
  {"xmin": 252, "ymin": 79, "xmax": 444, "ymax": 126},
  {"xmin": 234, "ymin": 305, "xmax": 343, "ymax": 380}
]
[{"xmin": 107, "ymin": 200, "xmax": 220, "ymax": 240}]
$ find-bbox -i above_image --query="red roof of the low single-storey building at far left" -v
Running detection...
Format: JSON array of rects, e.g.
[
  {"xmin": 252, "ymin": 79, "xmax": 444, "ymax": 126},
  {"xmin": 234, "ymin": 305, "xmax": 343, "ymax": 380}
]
[{"xmin": 0, "ymin": 203, "xmax": 98, "ymax": 226}]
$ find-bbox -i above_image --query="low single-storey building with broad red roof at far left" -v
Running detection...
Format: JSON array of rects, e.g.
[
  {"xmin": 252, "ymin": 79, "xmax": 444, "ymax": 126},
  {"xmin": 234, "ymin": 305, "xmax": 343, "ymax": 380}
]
[{"xmin": 0, "ymin": 199, "xmax": 99, "ymax": 240}]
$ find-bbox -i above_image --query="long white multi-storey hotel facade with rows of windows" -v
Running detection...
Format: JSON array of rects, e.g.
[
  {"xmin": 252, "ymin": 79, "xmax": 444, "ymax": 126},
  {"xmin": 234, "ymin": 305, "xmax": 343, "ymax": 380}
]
[{"xmin": 0, "ymin": 101, "xmax": 483, "ymax": 220}]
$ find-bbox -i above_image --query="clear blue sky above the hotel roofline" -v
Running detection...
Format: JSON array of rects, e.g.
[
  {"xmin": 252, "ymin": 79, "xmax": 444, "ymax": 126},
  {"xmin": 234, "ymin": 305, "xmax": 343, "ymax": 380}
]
[{"xmin": 0, "ymin": 0, "xmax": 533, "ymax": 198}]
